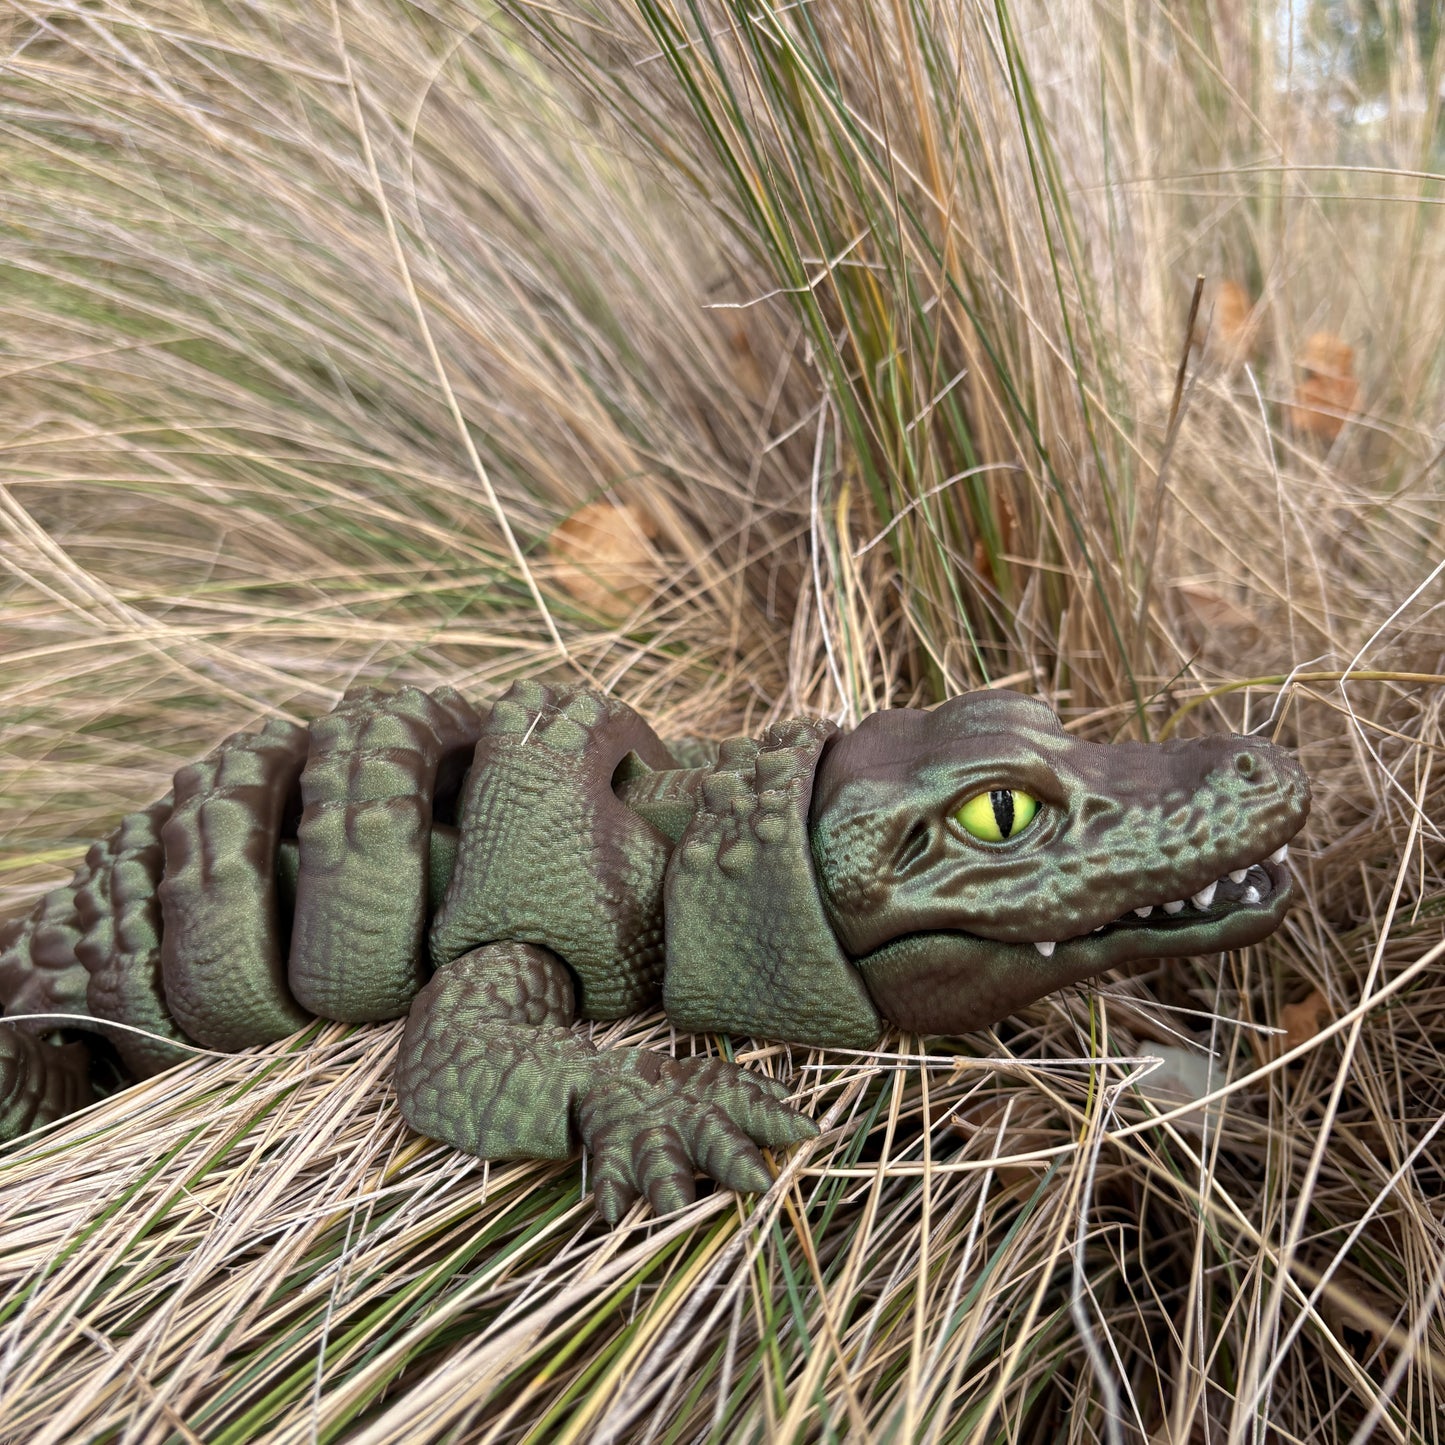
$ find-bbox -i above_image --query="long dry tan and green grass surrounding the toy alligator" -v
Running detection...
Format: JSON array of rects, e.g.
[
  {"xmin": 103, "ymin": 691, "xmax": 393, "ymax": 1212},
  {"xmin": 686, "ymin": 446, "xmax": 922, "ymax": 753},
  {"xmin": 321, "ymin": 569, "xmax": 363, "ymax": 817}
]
[{"xmin": 0, "ymin": 0, "xmax": 1445, "ymax": 1445}]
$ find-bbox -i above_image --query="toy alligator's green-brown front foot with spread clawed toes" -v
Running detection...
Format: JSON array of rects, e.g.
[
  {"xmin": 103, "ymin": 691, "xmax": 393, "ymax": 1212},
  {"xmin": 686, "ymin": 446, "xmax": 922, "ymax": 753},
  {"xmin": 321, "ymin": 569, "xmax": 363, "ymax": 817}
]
[{"xmin": 577, "ymin": 1049, "xmax": 818, "ymax": 1224}]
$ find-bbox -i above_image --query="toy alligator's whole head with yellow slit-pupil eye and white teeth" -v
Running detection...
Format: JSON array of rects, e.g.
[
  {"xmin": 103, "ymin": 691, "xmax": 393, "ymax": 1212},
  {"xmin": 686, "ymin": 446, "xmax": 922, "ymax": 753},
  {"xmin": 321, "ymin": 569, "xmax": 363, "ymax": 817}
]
[{"xmin": 809, "ymin": 691, "xmax": 1309, "ymax": 1033}]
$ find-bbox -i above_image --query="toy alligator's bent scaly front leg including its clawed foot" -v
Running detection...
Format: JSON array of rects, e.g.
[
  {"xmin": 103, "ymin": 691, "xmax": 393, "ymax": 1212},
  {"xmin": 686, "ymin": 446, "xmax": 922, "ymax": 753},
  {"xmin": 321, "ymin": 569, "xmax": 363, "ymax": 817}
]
[{"xmin": 396, "ymin": 944, "xmax": 816, "ymax": 1224}]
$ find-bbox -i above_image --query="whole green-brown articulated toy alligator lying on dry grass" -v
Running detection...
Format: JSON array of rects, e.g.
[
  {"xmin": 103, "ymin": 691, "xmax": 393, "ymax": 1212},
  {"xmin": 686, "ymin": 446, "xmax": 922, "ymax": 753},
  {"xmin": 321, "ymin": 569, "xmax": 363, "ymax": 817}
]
[{"xmin": 0, "ymin": 682, "xmax": 1309, "ymax": 1221}]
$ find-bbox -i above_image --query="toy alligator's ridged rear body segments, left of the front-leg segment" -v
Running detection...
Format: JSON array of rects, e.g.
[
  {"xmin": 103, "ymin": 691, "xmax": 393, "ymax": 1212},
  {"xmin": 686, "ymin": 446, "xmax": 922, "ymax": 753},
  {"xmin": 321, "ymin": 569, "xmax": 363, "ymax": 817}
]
[{"xmin": 0, "ymin": 688, "xmax": 480, "ymax": 1139}]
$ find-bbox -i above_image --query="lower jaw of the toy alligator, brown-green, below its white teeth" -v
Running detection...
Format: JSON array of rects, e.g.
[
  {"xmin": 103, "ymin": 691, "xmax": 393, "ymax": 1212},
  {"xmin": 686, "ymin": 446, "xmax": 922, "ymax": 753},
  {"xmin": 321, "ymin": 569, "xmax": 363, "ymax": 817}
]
[{"xmin": 854, "ymin": 864, "xmax": 1293, "ymax": 1033}]
